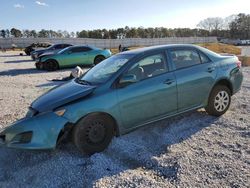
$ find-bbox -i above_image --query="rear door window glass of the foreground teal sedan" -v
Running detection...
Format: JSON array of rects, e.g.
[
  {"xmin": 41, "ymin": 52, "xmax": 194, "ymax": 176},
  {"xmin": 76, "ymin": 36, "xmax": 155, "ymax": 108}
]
[{"xmin": 170, "ymin": 49, "xmax": 201, "ymax": 69}]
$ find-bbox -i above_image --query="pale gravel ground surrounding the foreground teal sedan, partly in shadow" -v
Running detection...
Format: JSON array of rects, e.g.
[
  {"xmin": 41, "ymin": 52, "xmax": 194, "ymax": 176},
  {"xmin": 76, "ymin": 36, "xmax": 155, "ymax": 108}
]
[{"xmin": 0, "ymin": 52, "xmax": 250, "ymax": 187}]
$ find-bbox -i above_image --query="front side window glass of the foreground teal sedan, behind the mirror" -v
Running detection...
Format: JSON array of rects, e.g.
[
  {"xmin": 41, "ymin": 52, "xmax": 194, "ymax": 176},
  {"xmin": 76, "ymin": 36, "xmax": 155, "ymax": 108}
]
[{"xmin": 125, "ymin": 53, "xmax": 167, "ymax": 82}]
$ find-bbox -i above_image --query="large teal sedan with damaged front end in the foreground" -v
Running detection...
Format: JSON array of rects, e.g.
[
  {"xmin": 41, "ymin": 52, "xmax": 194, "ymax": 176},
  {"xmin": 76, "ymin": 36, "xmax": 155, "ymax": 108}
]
[{"xmin": 0, "ymin": 45, "xmax": 243, "ymax": 154}]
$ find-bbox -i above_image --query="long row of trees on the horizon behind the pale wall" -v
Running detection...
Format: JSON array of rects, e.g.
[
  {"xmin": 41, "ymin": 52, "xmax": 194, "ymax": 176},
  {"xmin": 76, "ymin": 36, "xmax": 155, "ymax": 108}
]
[{"xmin": 0, "ymin": 13, "xmax": 250, "ymax": 39}]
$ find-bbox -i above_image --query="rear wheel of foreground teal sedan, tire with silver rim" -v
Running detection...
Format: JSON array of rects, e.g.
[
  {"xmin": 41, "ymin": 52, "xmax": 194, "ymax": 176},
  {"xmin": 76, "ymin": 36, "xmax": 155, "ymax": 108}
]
[{"xmin": 205, "ymin": 85, "xmax": 231, "ymax": 116}]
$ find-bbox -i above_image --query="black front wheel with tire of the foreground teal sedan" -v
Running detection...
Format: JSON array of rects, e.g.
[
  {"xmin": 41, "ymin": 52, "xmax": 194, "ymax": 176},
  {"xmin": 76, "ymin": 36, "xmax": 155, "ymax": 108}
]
[{"xmin": 72, "ymin": 114, "xmax": 115, "ymax": 155}]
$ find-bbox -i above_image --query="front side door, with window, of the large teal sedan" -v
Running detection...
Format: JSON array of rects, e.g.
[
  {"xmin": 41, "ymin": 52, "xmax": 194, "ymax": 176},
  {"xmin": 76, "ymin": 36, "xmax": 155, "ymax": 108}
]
[{"xmin": 117, "ymin": 53, "xmax": 177, "ymax": 129}]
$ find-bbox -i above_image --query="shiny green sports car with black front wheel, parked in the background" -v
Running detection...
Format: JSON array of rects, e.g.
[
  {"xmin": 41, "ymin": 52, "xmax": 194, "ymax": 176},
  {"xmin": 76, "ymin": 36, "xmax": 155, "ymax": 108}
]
[{"xmin": 35, "ymin": 46, "xmax": 112, "ymax": 71}]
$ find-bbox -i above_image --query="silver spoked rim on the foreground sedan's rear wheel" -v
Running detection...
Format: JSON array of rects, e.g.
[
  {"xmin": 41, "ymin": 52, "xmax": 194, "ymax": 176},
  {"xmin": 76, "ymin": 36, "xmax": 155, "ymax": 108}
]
[{"xmin": 214, "ymin": 91, "xmax": 229, "ymax": 112}]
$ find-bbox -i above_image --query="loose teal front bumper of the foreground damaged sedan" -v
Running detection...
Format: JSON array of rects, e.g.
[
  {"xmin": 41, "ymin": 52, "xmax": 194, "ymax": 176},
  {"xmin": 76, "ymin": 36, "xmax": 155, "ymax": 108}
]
[{"xmin": 0, "ymin": 112, "xmax": 68, "ymax": 149}]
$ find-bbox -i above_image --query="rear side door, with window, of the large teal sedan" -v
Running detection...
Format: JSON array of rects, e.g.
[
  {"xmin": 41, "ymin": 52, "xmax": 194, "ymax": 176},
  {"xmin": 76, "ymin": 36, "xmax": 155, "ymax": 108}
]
[{"xmin": 168, "ymin": 48, "xmax": 217, "ymax": 111}]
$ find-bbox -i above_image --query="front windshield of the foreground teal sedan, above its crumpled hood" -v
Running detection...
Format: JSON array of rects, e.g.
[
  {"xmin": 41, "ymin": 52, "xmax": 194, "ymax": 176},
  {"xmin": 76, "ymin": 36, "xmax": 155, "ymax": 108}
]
[{"xmin": 80, "ymin": 54, "xmax": 132, "ymax": 84}]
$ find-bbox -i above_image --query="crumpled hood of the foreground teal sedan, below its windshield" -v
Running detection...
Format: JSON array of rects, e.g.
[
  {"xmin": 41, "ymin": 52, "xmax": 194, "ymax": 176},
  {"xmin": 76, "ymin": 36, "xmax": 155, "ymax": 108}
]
[{"xmin": 31, "ymin": 80, "xmax": 96, "ymax": 112}]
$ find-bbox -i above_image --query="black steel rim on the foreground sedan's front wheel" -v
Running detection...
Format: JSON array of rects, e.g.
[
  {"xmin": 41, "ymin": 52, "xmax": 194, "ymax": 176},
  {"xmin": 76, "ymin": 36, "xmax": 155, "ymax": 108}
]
[{"xmin": 86, "ymin": 122, "xmax": 106, "ymax": 144}]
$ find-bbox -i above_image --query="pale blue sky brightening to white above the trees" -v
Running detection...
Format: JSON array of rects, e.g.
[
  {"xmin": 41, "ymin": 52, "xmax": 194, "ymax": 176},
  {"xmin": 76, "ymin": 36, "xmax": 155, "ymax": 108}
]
[{"xmin": 0, "ymin": 0, "xmax": 250, "ymax": 31}]
